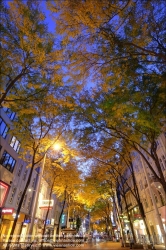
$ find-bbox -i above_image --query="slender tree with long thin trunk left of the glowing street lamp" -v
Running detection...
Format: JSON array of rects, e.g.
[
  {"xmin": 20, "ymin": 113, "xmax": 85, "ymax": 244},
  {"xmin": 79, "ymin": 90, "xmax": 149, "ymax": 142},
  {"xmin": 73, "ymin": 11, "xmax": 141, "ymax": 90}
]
[{"xmin": 6, "ymin": 98, "xmax": 64, "ymax": 249}]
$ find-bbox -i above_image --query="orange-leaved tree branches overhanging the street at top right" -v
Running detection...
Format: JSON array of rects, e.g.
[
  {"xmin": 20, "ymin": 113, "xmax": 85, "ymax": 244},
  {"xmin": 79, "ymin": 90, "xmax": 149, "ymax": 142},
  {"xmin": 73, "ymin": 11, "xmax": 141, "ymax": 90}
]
[{"xmin": 48, "ymin": 0, "xmax": 166, "ymax": 88}]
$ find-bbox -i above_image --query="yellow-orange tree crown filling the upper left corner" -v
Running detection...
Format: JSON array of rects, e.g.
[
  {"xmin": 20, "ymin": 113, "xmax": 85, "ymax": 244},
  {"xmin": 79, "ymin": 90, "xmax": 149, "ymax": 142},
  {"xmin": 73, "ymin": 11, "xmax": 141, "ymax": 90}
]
[{"xmin": 0, "ymin": 0, "xmax": 60, "ymax": 105}]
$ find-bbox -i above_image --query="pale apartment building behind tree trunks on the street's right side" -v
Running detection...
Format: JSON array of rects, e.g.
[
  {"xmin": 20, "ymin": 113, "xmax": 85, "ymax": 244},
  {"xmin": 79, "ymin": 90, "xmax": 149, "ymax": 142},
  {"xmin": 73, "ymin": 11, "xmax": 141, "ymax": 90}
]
[{"xmin": 116, "ymin": 133, "xmax": 166, "ymax": 244}]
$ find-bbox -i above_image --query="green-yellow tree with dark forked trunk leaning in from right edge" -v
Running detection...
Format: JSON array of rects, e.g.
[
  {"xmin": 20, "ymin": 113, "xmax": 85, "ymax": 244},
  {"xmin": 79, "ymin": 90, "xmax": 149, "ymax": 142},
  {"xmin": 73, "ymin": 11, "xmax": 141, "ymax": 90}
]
[{"xmin": 72, "ymin": 80, "xmax": 166, "ymax": 191}]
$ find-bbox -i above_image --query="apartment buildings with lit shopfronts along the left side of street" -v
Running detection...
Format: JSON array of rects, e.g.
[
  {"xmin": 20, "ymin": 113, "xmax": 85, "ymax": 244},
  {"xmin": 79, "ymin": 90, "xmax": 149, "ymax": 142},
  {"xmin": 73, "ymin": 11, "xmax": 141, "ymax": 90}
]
[{"xmin": 0, "ymin": 108, "xmax": 61, "ymax": 242}]
